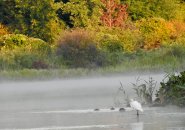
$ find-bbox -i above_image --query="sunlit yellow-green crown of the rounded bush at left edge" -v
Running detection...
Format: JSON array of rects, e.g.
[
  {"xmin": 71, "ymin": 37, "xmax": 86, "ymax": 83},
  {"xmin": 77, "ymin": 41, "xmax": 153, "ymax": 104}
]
[{"xmin": 0, "ymin": 34, "xmax": 51, "ymax": 56}]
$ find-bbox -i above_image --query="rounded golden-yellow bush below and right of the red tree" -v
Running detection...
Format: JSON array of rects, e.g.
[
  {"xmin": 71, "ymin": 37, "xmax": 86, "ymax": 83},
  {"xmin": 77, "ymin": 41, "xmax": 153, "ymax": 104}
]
[{"xmin": 136, "ymin": 18, "xmax": 175, "ymax": 50}]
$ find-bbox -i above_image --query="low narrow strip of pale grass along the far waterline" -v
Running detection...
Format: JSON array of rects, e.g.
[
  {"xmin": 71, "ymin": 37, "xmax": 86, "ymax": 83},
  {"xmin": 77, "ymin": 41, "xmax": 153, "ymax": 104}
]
[{"xmin": 0, "ymin": 63, "xmax": 184, "ymax": 82}]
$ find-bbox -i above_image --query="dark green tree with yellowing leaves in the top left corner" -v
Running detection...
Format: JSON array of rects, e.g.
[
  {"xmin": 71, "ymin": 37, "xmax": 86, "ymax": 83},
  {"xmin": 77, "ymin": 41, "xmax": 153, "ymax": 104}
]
[{"xmin": 0, "ymin": 0, "xmax": 61, "ymax": 42}]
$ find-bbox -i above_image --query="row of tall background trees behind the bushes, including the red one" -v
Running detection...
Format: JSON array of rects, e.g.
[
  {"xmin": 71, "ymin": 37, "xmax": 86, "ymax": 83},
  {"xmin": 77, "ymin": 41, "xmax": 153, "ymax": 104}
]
[{"xmin": 0, "ymin": 0, "xmax": 185, "ymax": 42}]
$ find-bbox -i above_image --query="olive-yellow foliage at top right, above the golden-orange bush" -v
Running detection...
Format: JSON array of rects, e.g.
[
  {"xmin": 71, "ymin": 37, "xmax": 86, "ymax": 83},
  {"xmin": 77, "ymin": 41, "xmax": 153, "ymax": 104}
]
[{"xmin": 124, "ymin": 0, "xmax": 182, "ymax": 20}]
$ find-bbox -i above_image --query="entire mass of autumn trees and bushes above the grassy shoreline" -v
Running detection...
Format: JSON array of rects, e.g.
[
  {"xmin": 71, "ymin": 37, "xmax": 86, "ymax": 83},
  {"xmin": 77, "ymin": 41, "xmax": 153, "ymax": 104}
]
[{"xmin": 0, "ymin": 0, "xmax": 185, "ymax": 69}]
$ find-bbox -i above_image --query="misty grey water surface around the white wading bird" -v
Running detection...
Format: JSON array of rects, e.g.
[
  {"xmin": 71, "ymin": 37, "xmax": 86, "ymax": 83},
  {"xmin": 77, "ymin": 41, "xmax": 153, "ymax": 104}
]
[{"xmin": 0, "ymin": 74, "xmax": 185, "ymax": 130}]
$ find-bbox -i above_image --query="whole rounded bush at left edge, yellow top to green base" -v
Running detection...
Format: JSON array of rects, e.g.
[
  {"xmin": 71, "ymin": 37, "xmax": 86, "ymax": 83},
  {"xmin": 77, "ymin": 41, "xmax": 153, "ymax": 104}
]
[{"xmin": 0, "ymin": 34, "xmax": 51, "ymax": 69}]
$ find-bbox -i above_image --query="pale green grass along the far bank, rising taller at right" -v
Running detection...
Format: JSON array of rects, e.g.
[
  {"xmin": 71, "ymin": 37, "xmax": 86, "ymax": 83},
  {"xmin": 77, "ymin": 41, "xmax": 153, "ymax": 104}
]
[{"xmin": 0, "ymin": 48, "xmax": 185, "ymax": 80}]
